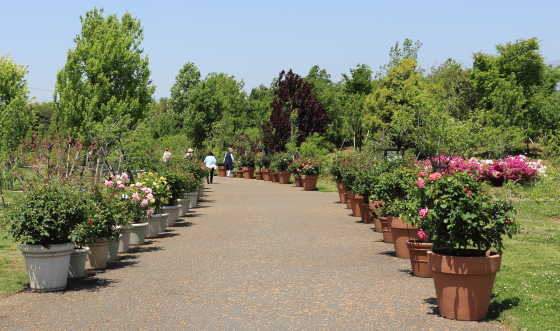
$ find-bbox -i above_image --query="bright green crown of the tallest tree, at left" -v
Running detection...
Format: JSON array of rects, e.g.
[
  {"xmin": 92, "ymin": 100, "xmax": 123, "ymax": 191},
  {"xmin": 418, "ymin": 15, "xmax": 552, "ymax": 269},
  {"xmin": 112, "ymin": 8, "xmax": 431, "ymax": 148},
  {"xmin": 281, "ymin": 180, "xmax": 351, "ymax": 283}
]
[{"xmin": 54, "ymin": 8, "xmax": 155, "ymax": 136}]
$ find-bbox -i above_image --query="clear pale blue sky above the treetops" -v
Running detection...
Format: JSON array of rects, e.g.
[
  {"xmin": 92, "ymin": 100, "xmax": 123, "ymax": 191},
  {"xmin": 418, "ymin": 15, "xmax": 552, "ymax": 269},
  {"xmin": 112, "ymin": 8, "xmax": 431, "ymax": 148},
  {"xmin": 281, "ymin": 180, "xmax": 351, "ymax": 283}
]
[{"xmin": 0, "ymin": 0, "xmax": 560, "ymax": 101}]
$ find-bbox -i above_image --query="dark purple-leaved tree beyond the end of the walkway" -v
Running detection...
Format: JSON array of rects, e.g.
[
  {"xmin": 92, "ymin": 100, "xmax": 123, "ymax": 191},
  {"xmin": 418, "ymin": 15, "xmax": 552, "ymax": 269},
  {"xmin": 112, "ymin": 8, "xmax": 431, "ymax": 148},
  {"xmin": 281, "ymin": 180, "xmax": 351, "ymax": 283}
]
[{"xmin": 264, "ymin": 69, "xmax": 327, "ymax": 152}]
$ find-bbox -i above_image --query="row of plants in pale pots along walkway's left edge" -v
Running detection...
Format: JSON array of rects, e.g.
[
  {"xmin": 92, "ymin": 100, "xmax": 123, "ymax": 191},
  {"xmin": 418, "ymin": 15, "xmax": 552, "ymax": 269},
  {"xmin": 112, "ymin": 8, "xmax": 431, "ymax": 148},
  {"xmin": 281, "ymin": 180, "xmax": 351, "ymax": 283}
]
[{"xmin": 0, "ymin": 160, "xmax": 207, "ymax": 291}]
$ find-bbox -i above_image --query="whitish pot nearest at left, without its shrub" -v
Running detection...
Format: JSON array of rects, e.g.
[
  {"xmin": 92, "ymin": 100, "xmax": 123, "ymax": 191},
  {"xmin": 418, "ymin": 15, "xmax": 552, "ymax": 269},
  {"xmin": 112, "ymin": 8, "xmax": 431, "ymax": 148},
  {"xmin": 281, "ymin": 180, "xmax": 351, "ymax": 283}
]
[{"xmin": 19, "ymin": 242, "xmax": 74, "ymax": 291}]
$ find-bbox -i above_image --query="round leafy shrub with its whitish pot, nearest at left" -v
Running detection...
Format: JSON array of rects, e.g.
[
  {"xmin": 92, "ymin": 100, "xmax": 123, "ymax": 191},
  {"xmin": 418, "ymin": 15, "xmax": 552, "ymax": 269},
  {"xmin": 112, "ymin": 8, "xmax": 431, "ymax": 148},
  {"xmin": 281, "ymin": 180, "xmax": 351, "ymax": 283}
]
[{"xmin": 0, "ymin": 181, "xmax": 89, "ymax": 291}]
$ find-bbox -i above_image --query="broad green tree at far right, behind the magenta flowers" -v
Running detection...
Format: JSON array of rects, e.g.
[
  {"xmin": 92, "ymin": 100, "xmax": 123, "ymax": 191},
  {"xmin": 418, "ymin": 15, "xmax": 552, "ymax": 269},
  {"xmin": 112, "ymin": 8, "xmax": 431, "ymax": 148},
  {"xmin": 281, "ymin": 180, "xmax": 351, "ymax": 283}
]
[{"xmin": 470, "ymin": 38, "xmax": 560, "ymax": 153}]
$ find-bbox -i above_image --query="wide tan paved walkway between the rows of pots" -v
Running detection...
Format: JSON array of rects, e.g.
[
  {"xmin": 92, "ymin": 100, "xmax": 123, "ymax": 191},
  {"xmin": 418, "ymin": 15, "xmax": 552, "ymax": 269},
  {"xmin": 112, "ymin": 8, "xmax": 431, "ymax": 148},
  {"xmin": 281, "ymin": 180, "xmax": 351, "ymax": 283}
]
[{"xmin": 0, "ymin": 178, "xmax": 502, "ymax": 330}]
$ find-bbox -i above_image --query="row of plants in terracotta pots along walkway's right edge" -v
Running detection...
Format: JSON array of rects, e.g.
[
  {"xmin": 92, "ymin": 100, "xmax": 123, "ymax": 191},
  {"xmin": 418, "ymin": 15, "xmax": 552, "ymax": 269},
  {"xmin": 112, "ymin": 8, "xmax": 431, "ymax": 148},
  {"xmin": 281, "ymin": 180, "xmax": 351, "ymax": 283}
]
[{"xmin": 331, "ymin": 155, "xmax": 543, "ymax": 320}]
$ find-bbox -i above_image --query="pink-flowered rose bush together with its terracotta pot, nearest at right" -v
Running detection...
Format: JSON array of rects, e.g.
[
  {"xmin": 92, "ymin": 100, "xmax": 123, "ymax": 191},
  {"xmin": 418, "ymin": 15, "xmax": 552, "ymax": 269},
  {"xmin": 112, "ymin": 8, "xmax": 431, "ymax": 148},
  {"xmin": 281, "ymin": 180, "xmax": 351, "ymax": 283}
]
[{"xmin": 405, "ymin": 172, "xmax": 517, "ymax": 320}]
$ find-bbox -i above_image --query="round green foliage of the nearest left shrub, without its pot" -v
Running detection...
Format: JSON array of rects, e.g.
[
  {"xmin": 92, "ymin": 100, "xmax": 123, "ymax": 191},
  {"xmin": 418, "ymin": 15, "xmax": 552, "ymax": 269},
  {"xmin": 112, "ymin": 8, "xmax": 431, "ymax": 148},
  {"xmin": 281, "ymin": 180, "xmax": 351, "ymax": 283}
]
[{"xmin": 0, "ymin": 182, "xmax": 89, "ymax": 248}]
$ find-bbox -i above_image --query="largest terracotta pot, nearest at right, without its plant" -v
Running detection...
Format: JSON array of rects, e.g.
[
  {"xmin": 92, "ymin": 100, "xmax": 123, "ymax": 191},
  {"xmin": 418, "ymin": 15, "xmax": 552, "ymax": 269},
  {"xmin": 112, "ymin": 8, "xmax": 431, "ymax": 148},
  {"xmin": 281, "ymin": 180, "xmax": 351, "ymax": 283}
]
[{"xmin": 428, "ymin": 249, "xmax": 502, "ymax": 321}]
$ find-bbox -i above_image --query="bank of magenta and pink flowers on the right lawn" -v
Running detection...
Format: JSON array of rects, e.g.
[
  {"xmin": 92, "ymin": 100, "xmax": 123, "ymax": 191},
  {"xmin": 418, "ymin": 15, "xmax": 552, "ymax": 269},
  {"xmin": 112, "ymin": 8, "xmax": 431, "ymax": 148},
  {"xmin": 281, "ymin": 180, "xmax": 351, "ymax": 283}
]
[{"xmin": 417, "ymin": 155, "xmax": 547, "ymax": 185}]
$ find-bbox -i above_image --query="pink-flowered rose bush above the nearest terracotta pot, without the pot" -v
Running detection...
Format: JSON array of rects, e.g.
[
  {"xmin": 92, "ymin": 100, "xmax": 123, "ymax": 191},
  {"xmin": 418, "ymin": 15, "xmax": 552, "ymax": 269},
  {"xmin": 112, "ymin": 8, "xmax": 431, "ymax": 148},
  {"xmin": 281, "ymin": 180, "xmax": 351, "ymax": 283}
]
[{"xmin": 401, "ymin": 172, "xmax": 517, "ymax": 256}]
